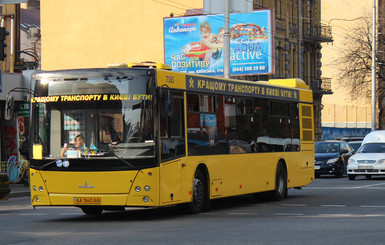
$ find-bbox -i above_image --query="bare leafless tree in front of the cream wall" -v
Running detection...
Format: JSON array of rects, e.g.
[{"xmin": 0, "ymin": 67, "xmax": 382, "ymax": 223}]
[{"xmin": 336, "ymin": 9, "xmax": 385, "ymax": 129}]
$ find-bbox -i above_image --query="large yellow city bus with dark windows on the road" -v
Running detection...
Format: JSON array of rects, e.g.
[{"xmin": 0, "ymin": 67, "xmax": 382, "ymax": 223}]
[{"xmin": 30, "ymin": 67, "xmax": 314, "ymax": 215}]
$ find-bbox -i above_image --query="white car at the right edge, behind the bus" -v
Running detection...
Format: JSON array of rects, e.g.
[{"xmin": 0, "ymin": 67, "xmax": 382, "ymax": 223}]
[{"xmin": 347, "ymin": 130, "xmax": 385, "ymax": 180}]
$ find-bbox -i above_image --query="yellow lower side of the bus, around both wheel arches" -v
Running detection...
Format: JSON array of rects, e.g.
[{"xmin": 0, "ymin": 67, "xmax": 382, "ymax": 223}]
[{"xmin": 160, "ymin": 152, "xmax": 314, "ymax": 205}]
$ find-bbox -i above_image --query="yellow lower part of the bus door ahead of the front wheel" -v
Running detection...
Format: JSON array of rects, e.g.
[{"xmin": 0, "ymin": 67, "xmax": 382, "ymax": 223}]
[{"xmin": 160, "ymin": 159, "xmax": 182, "ymax": 204}]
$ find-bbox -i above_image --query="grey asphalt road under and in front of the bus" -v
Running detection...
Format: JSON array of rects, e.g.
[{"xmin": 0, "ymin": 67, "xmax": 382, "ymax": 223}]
[{"xmin": 0, "ymin": 177, "xmax": 385, "ymax": 245}]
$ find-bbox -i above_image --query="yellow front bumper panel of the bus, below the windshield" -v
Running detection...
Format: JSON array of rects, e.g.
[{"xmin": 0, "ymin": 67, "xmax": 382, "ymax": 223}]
[{"xmin": 30, "ymin": 168, "xmax": 159, "ymax": 206}]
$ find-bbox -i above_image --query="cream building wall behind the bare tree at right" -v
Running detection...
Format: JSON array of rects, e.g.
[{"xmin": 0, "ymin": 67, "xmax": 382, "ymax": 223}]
[{"xmin": 322, "ymin": 0, "xmax": 385, "ymax": 139}]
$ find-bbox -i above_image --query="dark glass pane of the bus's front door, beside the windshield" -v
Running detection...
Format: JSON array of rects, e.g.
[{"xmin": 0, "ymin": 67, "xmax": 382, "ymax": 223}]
[{"xmin": 160, "ymin": 92, "xmax": 185, "ymax": 162}]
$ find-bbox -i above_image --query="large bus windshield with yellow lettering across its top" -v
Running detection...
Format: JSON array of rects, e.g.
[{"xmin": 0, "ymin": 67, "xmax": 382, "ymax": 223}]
[{"xmin": 31, "ymin": 68, "xmax": 156, "ymax": 169}]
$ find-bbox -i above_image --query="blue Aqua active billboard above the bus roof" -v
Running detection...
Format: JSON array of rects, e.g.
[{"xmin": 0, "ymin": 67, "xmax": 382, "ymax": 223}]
[{"xmin": 163, "ymin": 10, "xmax": 273, "ymax": 76}]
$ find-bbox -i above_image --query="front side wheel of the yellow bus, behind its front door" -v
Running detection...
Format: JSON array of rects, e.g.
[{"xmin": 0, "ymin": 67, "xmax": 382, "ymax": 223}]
[{"xmin": 187, "ymin": 168, "xmax": 208, "ymax": 214}]
